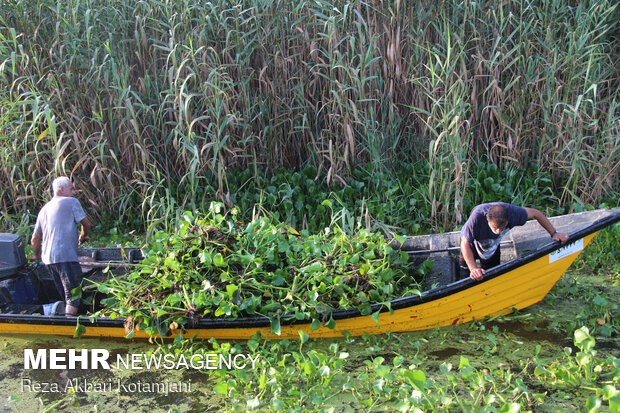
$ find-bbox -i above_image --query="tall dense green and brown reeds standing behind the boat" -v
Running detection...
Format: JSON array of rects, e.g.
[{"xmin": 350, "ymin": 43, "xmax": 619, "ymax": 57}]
[{"xmin": 0, "ymin": 0, "xmax": 620, "ymax": 232}]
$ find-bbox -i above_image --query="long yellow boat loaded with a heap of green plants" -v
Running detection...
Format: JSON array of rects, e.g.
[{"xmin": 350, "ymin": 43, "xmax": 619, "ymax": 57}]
[{"xmin": 0, "ymin": 209, "xmax": 620, "ymax": 340}]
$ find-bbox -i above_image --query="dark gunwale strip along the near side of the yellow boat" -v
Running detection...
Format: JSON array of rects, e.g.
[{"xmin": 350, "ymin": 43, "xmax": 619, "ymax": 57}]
[{"xmin": 0, "ymin": 209, "xmax": 620, "ymax": 329}]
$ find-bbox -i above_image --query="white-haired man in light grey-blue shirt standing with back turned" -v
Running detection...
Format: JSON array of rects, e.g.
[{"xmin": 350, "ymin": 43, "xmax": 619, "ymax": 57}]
[{"xmin": 30, "ymin": 176, "xmax": 90, "ymax": 315}]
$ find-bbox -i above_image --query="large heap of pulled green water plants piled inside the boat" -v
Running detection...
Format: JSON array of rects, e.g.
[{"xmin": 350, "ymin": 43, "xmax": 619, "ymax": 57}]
[{"xmin": 96, "ymin": 201, "xmax": 429, "ymax": 334}]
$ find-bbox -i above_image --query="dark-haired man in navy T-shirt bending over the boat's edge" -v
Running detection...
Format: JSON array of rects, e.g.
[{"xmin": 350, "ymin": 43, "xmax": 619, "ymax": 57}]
[{"xmin": 460, "ymin": 202, "xmax": 568, "ymax": 281}]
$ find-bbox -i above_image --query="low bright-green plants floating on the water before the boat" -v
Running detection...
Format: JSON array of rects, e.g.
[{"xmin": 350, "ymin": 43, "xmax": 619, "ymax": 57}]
[{"xmin": 186, "ymin": 325, "xmax": 620, "ymax": 412}]
